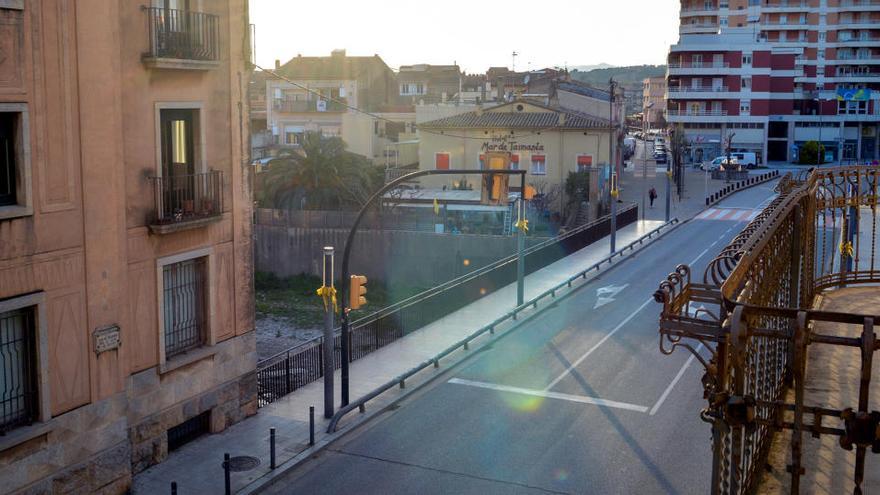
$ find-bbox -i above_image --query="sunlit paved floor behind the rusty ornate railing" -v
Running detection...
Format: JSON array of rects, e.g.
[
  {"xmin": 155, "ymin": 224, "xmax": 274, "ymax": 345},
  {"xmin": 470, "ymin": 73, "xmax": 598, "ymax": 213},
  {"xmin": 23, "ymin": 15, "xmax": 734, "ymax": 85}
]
[{"xmin": 757, "ymin": 287, "xmax": 880, "ymax": 495}]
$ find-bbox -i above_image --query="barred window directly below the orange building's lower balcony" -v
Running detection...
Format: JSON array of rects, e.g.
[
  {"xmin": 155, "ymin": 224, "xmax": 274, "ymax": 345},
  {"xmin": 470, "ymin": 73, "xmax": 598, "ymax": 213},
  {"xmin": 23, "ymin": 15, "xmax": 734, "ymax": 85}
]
[{"xmin": 162, "ymin": 258, "xmax": 207, "ymax": 359}]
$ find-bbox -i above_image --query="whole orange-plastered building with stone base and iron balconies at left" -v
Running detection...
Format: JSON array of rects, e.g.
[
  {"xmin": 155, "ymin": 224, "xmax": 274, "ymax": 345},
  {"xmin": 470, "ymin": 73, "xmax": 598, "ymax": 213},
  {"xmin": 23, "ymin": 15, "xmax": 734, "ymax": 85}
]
[{"xmin": 0, "ymin": 0, "xmax": 256, "ymax": 493}]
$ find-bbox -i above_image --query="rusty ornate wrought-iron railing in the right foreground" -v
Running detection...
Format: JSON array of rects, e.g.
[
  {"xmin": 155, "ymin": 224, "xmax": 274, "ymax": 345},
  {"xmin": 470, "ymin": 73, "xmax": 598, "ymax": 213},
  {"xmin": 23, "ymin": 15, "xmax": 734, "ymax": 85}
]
[{"xmin": 655, "ymin": 167, "xmax": 880, "ymax": 494}]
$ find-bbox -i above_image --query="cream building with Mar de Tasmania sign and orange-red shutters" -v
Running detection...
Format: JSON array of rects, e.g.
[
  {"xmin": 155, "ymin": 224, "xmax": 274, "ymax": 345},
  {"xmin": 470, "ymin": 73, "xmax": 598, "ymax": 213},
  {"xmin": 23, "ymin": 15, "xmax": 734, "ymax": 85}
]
[{"xmin": 419, "ymin": 100, "xmax": 611, "ymax": 219}]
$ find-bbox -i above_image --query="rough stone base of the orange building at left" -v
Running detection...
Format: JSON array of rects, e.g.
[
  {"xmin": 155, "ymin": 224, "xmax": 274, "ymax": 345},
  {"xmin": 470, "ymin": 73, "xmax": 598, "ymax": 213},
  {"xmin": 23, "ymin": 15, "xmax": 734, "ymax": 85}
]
[{"xmin": 0, "ymin": 332, "xmax": 257, "ymax": 495}]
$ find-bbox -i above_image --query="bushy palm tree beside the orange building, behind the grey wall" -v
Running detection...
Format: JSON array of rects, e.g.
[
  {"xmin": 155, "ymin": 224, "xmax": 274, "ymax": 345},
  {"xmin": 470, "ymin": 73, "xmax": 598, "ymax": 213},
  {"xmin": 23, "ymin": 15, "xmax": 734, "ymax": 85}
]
[{"xmin": 257, "ymin": 132, "xmax": 383, "ymax": 210}]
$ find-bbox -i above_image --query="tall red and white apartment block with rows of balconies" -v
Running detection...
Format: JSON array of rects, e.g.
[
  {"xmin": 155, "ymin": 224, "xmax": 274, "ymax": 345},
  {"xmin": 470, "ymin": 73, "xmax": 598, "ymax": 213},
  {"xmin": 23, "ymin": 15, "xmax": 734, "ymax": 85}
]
[{"xmin": 667, "ymin": 0, "xmax": 880, "ymax": 162}]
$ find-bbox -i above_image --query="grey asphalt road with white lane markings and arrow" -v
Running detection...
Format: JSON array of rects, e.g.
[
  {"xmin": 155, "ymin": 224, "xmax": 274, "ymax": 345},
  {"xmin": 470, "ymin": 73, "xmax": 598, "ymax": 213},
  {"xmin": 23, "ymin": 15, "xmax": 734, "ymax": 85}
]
[{"xmin": 267, "ymin": 184, "xmax": 773, "ymax": 495}]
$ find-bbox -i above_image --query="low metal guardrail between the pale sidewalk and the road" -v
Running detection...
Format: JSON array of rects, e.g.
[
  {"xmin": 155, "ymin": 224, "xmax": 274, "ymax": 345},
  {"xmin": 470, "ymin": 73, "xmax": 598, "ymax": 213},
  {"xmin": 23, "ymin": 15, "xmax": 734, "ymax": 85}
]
[{"xmin": 327, "ymin": 218, "xmax": 679, "ymax": 433}]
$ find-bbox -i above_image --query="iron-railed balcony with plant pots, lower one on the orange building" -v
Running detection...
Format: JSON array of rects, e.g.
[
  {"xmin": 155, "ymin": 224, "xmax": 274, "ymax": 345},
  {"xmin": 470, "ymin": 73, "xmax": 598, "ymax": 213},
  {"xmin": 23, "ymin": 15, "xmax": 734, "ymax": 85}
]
[{"xmin": 150, "ymin": 171, "xmax": 223, "ymax": 234}]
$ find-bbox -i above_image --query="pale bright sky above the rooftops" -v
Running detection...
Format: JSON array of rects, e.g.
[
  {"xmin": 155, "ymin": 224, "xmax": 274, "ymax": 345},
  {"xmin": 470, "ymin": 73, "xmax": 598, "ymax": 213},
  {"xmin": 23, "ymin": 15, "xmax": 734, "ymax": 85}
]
[{"xmin": 250, "ymin": 0, "xmax": 680, "ymax": 73}]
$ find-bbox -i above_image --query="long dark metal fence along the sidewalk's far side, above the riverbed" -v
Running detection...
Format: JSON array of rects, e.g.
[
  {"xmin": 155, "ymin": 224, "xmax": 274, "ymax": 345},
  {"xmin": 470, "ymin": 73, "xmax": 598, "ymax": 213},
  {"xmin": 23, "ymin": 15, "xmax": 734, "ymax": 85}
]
[{"xmin": 257, "ymin": 205, "xmax": 638, "ymax": 407}]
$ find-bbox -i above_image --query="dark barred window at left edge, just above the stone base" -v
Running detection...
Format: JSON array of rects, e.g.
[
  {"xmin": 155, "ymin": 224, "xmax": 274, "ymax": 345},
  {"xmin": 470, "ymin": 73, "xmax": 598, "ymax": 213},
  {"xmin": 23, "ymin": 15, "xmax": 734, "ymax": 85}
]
[{"xmin": 0, "ymin": 308, "xmax": 38, "ymax": 435}]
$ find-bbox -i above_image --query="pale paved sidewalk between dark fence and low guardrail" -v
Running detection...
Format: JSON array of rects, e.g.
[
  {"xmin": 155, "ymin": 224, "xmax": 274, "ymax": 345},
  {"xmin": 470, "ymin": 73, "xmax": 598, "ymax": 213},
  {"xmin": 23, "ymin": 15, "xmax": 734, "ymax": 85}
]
[{"xmin": 133, "ymin": 220, "xmax": 662, "ymax": 495}]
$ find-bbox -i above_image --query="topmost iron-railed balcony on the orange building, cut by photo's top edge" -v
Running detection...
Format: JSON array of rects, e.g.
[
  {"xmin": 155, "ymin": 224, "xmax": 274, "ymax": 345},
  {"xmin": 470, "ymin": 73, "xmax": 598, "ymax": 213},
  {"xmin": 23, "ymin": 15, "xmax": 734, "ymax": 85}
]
[{"xmin": 142, "ymin": 7, "xmax": 220, "ymax": 70}]
